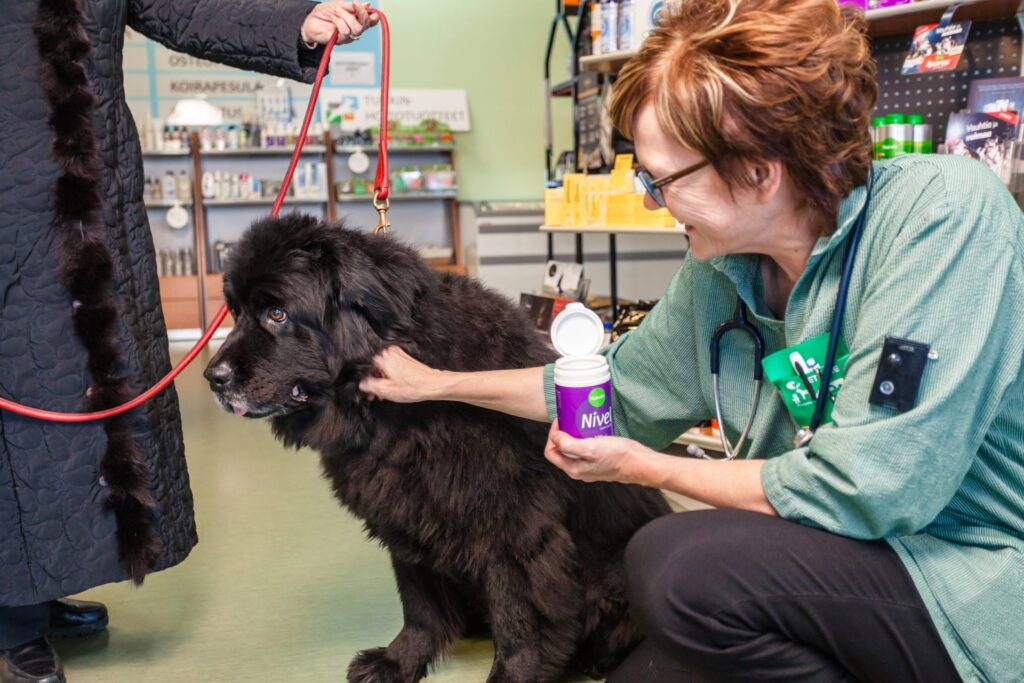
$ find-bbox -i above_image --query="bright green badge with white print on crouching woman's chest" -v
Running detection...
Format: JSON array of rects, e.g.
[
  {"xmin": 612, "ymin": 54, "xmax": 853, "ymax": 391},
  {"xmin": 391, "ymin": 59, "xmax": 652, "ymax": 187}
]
[{"xmin": 761, "ymin": 332, "xmax": 850, "ymax": 428}]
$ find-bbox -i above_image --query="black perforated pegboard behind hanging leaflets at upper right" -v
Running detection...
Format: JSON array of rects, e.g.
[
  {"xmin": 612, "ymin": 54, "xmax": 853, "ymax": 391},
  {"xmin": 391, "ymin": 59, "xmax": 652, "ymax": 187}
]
[{"xmin": 871, "ymin": 16, "xmax": 1021, "ymax": 148}]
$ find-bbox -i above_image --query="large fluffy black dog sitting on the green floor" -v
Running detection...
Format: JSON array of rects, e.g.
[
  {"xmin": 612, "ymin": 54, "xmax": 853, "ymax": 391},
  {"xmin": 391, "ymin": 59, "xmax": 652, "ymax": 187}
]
[{"xmin": 206, "ymin": 215, "xmax": 669, "ymax": 683}]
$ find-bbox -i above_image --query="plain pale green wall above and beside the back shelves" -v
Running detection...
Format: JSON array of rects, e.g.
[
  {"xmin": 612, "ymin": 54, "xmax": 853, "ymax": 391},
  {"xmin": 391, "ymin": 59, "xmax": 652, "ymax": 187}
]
[{"xmin": 382, "ymin": 0, "xmax": 572, "ymax": 201}]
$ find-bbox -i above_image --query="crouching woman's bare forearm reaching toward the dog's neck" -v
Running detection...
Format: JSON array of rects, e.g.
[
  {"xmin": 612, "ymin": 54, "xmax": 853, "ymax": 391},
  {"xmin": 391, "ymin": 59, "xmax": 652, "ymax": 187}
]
[{"xmin": 428, "ymin": 368, "xmax": 548, "ymax": 422}]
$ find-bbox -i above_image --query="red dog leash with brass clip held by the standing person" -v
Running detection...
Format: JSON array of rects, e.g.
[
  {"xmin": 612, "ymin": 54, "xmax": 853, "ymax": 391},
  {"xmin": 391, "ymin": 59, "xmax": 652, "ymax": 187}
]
[{"xmin": 0, "ymin": 9, "xmax": 391, "ymax": 422}]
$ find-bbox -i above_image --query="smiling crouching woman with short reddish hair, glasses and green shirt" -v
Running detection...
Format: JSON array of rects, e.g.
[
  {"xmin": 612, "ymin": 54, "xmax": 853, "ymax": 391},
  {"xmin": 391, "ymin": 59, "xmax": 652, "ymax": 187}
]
[{"xmin": 362, "ymin": 0, "xmax": 1024, "ymax": 683}]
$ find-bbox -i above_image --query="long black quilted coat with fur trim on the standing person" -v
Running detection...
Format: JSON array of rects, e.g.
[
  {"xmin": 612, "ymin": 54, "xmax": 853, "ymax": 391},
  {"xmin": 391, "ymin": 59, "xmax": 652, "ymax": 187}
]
[{"xmin": 0, "ymin": 0, "xmax": 319, "ymax": 606}]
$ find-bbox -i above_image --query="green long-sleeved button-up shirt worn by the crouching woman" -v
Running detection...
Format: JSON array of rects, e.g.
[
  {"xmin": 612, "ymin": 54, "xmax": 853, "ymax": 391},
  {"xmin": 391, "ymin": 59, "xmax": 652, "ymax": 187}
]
[{"xmin": 545, "ymin": 156, "xmax": 1024, "ymax": 682}]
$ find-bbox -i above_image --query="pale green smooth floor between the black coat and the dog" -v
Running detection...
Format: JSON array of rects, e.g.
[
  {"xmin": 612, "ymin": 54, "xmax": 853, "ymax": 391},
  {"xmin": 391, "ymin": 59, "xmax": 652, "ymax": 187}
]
[{"xmin": 57, "ymin": 349, "xmax": 569, "ymax": 683}]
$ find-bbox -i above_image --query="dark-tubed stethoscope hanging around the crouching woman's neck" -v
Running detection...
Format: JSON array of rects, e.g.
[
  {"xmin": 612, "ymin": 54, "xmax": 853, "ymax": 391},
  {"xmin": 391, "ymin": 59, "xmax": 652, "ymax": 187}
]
[{"xmin": 687, "ymin": 169, "xmax": 874, "ymax": 460}]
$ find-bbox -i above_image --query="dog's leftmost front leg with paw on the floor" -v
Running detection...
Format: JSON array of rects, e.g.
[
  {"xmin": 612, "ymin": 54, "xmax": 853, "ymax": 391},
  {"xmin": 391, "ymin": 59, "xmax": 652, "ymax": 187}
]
[{"xmin": 348, "ymin": 557, "xmax": 466, "ymax": 683}]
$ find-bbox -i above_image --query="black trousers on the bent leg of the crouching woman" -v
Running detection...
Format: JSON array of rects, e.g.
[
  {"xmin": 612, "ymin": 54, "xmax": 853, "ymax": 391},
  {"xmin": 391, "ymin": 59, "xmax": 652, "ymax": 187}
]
[{"xmin": 608, "ymin": 510, "xmax": 961, "ymax": 683}]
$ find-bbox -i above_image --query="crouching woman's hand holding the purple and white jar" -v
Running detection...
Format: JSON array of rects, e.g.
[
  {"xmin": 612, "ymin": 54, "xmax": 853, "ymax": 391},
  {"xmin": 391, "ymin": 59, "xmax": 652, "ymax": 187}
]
[{"xmin": 544, "ymin": 420, "xmax": 664, "ymax": 485}]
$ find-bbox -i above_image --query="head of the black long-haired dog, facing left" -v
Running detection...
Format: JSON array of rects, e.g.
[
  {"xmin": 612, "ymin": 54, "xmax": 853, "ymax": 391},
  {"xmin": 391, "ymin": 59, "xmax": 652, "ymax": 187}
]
[{"xmin": 204, "ymin": 214, "xmax": 428, "ymax": 418}]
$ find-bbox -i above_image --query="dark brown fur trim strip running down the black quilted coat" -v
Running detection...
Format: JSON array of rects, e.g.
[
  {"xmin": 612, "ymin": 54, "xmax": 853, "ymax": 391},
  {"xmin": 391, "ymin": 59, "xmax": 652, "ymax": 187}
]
[{"xmin": 34, "ymin": 0, "xmax": 161, "ymax": 584}]
